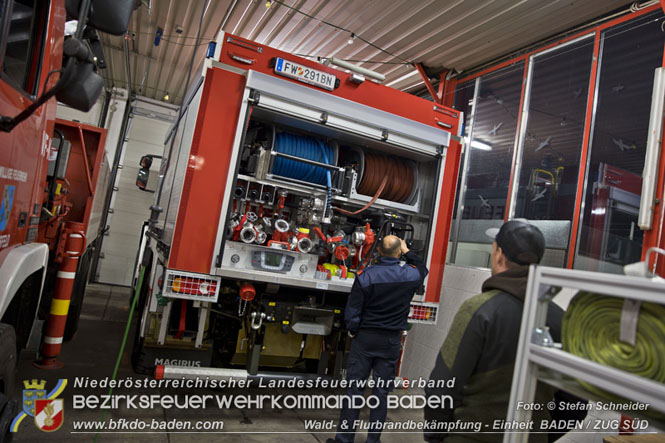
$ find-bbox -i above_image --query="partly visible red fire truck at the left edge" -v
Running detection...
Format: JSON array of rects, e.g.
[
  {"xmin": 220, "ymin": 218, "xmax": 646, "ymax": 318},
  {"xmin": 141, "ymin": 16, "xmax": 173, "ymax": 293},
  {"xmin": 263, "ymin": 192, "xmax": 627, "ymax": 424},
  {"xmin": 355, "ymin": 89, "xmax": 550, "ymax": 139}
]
[{"xmin": 0, "ymin": 0, "xmax": 135, "ymax": 440}]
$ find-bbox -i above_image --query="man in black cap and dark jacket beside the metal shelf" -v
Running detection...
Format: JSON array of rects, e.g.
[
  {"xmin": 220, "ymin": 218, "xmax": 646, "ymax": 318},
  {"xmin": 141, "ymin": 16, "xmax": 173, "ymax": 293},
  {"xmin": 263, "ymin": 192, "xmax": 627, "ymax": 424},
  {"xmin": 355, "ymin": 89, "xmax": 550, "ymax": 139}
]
[{"xmin": 425, "ymin": 220, "xmax": 585, "ymax": 443}]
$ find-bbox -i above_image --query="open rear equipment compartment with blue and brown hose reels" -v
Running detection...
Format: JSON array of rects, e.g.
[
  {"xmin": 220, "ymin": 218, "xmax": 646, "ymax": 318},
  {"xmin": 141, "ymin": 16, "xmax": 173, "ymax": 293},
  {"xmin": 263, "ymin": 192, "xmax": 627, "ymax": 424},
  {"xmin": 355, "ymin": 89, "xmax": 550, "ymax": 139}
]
[{"xmin": 210, "ymin": 92, "xmax": 444, "ymax": 376}]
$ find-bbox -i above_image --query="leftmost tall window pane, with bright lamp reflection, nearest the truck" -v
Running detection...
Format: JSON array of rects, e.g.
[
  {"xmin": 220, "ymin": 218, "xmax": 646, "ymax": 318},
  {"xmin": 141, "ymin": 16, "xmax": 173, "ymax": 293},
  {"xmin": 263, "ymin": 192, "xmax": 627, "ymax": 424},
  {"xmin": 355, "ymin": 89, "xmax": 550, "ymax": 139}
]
[{"xmin": 450, "ymin": 61, "xmax": 524, "ymax": 267}]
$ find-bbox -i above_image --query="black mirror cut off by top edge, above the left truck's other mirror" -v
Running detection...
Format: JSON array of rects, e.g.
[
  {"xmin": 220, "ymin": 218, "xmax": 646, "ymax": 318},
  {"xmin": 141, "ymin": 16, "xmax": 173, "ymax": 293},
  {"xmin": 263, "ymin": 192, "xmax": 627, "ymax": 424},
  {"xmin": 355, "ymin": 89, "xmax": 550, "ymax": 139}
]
[{"xmin": 65, "ymin": 0, "xmax": 141, "ymax": 35}]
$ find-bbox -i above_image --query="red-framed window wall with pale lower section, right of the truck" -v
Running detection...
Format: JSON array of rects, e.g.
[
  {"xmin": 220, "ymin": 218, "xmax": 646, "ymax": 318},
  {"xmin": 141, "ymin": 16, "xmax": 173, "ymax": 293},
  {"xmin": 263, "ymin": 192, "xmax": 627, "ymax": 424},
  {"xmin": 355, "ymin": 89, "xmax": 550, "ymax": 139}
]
[{"xmin": 402, "ymin": 8, "xmax": 665, "ymax": 388}]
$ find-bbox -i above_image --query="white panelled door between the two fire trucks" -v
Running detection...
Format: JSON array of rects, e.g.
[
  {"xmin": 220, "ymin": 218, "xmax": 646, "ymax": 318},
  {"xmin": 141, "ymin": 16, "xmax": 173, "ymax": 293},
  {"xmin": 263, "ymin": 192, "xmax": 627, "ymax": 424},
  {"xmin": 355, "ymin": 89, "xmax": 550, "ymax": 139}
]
[{"xmin": 95, "ymin": 108, "xmax": 175, "ymax": 286}]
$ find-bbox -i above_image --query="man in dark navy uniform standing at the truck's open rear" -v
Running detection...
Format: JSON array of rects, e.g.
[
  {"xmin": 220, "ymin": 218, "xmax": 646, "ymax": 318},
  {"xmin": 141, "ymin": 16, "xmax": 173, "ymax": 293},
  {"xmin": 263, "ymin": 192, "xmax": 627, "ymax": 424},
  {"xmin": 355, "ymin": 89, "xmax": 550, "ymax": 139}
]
[{"xmin": 328, "ymin": 235, "xmax": 427, "ymax": 442}]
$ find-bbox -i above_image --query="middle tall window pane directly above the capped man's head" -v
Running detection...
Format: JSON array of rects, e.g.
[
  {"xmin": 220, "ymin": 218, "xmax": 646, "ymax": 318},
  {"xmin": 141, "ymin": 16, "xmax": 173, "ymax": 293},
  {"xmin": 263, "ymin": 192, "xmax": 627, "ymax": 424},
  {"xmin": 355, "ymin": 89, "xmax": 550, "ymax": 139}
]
[{"xmin": 511, "ymin": 34, "xmax": 594, "ymax": 267}]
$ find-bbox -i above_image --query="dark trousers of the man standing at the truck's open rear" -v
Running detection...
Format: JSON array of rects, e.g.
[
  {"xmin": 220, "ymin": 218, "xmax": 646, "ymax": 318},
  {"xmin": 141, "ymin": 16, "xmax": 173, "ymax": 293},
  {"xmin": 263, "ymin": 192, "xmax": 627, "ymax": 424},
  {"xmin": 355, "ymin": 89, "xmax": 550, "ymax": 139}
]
[{"xmin": 335, "ymin": 329, "xmax": 401, "ymax": 443}]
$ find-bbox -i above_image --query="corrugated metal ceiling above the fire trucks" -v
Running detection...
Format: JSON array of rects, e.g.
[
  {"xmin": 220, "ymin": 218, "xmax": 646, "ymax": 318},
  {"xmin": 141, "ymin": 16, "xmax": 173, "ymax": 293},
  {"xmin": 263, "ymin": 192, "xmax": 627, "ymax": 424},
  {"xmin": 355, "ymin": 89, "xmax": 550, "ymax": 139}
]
[{"xmin": 101, "ymin": 0, "xmax": 632, "ymax": 104}]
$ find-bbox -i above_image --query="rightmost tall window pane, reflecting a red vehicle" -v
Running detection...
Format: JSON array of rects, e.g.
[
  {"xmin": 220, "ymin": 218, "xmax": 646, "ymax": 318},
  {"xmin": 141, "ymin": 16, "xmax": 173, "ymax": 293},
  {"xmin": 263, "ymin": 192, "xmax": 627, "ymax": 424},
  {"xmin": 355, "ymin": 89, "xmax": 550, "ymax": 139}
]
[{"xmin": 574, "ymin": 11, "xmax": 665, "ymax": 273}]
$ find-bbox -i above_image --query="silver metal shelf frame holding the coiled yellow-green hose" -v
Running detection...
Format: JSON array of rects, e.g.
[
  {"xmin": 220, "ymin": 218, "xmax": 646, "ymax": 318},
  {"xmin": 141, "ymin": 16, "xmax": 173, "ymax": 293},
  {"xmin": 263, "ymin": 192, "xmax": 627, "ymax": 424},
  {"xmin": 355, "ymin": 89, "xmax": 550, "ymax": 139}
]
[{"xmin": 503, "ymin": 266, "xmax": 665, "ymax": 443}]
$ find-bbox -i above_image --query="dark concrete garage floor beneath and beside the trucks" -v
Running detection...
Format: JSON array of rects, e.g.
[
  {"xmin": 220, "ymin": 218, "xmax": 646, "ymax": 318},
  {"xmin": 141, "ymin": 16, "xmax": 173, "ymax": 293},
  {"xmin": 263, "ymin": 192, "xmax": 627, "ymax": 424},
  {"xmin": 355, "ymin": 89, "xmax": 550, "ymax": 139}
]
[{"xmin": 14, "ymin": 285, "xmax": 423, "ymax": 443}]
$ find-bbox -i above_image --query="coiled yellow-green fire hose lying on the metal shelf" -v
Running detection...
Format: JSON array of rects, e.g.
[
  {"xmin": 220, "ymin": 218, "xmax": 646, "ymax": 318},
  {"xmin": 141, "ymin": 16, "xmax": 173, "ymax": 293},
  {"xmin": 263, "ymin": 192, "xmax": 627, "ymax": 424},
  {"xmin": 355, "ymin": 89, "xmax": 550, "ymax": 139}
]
[{"xmin": 561, "ymin": 292, "xmax": 665, "ymax": 403}]
